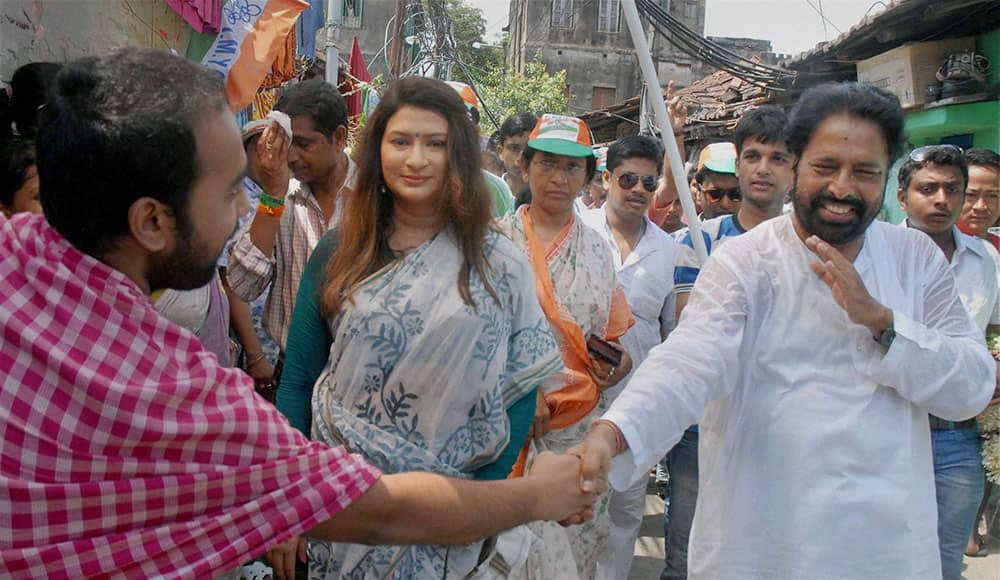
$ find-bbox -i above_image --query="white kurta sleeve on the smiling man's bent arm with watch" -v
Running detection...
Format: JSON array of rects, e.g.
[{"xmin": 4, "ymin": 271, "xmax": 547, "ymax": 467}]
[{"xmin": 869, "ymin": 246, "xmax": 997, "ymax": 421}]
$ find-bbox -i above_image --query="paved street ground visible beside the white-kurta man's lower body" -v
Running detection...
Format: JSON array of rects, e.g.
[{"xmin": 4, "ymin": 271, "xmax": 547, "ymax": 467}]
[{"xmin": 629, "ymin": 486, "xmax": 1000, "ymax": 580}]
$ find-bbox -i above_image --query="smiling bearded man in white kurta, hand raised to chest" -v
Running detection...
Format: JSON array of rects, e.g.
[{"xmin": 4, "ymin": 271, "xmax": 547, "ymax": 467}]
[{"xmin": 569, "ymin": 83, "xmax": 996, "ymax": 580}]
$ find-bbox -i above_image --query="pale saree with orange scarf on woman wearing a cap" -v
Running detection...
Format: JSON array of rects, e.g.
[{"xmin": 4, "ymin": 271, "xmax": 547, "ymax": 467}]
[{"xmin": 503, "ymin": 206, "xmax": 635, "ymax": 579}]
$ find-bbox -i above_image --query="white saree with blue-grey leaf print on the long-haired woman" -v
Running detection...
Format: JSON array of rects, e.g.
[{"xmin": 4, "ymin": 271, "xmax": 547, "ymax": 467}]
[{"xmin": 310, "ymin": 230, "xmax": 562, "ymax": 578}]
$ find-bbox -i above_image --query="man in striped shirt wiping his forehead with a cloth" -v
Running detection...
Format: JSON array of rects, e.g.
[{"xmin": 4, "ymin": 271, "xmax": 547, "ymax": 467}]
[{"xmin": 226, "ymin": 78, "xmax": 357, "ymax": 358}]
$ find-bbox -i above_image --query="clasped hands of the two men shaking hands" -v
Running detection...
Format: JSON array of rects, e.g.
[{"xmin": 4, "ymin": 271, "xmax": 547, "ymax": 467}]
[{"xmin": 525, "ymin": 422, "xmax": 621, "ymax": 526}]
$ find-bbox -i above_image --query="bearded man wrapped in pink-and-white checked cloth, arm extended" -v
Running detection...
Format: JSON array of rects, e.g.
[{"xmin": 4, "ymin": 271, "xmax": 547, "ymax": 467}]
[{"xmin": 0, "ymin": 49, "xmax": 600, "ymax": 578}]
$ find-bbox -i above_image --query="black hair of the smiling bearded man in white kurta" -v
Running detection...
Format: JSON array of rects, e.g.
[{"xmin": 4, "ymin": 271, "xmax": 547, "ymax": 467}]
[{"xmin": 785, "ymin": 82, "xmax": 906, "ymax": 166}]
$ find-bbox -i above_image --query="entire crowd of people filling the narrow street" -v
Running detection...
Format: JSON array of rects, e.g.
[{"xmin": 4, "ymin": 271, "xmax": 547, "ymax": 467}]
[{"xmin": 0, "ymin": 49, "xmax": 1000, "ymax": 580}]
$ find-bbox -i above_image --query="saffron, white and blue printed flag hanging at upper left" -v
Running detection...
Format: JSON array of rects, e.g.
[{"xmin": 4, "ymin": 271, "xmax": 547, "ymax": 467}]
[{"xmin": 201, "ymin": 0, "xmax": 309, "ymax": 111}]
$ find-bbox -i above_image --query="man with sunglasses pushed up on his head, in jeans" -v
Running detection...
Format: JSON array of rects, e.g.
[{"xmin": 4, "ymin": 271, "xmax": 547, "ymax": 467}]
[{"xmin": 897, "ymin": 145, "xmax": 1000, "ymax": 580}]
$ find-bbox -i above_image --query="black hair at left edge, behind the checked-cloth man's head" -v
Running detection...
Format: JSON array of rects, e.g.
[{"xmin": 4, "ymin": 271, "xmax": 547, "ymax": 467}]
[{"xmin": 0, "ymin": 62, "xmax": 62, "ymax": 143}]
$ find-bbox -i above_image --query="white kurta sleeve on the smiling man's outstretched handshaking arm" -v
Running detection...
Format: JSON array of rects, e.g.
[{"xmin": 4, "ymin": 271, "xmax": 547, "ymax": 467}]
[{"xmin": 604, "ymin": 260, "xmax": 748, "ymax": 490}]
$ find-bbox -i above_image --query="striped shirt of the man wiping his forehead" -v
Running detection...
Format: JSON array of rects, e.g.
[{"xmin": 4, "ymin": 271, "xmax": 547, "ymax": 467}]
[{"xmin": 226, "ymin": 157, "xmax": 358, "ymax": 350}]
